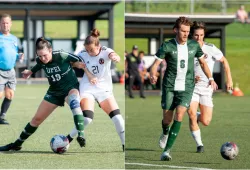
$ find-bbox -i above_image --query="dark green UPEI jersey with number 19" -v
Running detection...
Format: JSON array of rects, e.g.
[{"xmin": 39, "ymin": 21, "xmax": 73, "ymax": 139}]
[{"xmin": 31, "ymin": 51, "xmax": 81, "ymax": 96}]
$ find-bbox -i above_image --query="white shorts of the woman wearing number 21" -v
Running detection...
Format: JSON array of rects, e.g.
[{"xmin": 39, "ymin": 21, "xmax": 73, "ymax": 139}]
[{"xmin": 80, "ymin": 90, "xmax": 113, "ymax": 103}]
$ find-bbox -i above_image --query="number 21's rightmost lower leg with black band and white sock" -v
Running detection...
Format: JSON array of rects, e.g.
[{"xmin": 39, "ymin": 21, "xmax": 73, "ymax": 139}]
[{"xmin": 109, "ymin": 109, "xmax": 125, "ymax": 151}]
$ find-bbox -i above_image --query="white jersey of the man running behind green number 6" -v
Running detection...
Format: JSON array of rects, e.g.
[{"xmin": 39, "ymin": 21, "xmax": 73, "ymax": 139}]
[{"xmin": 194, "ymin": 42, "xmax": 223, "ymax": 86}]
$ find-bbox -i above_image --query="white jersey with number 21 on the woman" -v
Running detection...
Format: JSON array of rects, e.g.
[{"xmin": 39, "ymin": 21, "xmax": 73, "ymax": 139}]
[{"xmin": 78, "ymin": 46, "xmax": 114, "ymax": 91}]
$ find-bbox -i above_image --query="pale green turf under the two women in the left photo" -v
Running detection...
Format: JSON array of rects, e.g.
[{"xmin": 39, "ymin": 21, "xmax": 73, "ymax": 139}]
[{"xmin": 0, "ymin": 85, "xmax": 125, "ymax": 169}]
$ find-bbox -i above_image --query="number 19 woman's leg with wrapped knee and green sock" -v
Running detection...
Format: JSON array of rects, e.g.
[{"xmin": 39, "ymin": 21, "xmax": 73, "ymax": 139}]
[{"xmin": 68, "ymin": 89, "xmax": 86, "ymax": 147}]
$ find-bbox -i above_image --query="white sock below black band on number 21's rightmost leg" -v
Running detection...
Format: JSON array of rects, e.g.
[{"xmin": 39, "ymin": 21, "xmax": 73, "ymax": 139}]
[{"xmin": 112, "ymin": 114, "xmax": 125, "ymax": 145}]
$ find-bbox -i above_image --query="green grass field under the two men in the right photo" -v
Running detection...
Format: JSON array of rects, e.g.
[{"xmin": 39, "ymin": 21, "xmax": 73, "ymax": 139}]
[{"xmin": 125, "ymin": 94, "xmax": 250, "ymax": 169}]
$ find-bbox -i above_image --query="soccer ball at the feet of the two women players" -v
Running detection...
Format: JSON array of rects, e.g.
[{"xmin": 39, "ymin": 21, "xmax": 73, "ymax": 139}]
[{"xmin": 50, "ymin": 135, "xmax": 69, "ymax": 154}]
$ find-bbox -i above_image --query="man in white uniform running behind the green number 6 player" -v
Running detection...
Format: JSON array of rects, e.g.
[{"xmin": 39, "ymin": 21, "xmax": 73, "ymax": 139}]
[{"xmin": 188, "ymin": 21, "xmax": 233, "ymax": 153}]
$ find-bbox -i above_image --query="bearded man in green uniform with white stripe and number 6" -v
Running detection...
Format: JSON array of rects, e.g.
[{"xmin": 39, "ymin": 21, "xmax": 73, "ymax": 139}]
[{"xmin": 150, "ymin": 17, "xmax": 217, "ymax": 161}]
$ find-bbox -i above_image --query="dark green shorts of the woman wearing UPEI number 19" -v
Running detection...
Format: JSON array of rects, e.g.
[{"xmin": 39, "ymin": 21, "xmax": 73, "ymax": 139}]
[{"xmin": 43, "ymin": 84, "xmax": 79, "ymax": 106}]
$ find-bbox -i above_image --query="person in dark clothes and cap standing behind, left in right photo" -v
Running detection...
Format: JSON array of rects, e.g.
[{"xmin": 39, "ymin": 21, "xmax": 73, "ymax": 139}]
[{"xmin": 125, "ymin": 45, "xmax": 145, "ymax": 98}]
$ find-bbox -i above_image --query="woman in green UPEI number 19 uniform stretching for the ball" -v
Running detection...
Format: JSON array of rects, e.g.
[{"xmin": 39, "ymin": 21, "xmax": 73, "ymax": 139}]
[{"xmin": 0, "ymin": 38, "xmax": 94, "ymax": 151}]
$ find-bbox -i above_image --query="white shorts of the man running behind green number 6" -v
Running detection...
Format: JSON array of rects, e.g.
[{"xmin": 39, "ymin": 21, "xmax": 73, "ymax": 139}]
[{"xmin": 191, "ymin": 86, "xmax": 214, "ymax": 107}]
